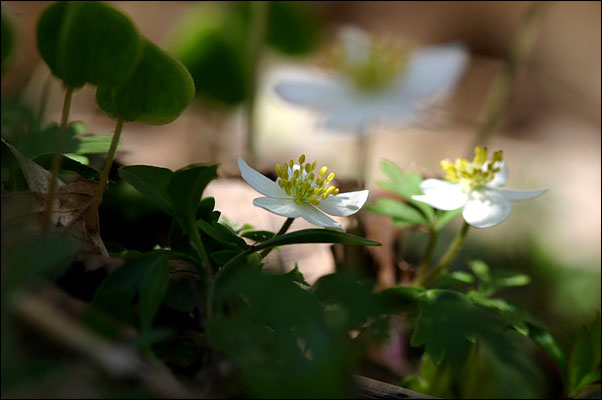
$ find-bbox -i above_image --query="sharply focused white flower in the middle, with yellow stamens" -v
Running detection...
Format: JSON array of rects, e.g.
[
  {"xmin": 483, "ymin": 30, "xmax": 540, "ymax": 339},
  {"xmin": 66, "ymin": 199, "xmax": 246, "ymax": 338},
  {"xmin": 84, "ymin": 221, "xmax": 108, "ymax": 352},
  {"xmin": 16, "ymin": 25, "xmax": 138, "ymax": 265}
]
[{"xmin": 238, "ymin": 155, "xmax": 368, "ymax": 231}]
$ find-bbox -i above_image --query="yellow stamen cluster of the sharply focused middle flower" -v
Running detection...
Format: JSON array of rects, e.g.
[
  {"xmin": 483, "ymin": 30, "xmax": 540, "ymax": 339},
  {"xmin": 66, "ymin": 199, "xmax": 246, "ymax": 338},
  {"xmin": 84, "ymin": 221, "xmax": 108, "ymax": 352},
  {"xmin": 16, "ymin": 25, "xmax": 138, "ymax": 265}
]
[{"xmin": 276, "ymin": 154, "xmax": 339, "ymax": 206}]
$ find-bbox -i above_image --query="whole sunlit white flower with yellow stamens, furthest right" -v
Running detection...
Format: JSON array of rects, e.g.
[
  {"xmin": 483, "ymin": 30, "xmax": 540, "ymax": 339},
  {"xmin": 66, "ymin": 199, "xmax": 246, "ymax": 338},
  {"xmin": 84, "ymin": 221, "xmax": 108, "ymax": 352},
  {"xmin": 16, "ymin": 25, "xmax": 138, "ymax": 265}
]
[{"xmin": 412, "ymin": 146, "xmax": 548, "ymax": 228}]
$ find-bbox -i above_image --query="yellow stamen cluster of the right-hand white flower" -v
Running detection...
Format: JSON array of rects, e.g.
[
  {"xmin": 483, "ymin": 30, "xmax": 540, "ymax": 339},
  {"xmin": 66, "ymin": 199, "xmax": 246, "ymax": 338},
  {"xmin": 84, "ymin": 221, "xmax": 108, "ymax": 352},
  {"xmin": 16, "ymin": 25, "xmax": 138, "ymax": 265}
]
[{"xmin": 441, "ymin": 146, "xmax": 502, "ymax": 191}]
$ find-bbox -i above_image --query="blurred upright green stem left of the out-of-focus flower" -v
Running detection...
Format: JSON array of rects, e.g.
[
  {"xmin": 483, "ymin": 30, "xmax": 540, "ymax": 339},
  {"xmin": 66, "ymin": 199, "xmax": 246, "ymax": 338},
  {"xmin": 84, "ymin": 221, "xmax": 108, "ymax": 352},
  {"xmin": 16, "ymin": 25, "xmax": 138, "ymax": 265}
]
[{"xmin": 245, "ymin": 1, "xmax": 268, "ymax": 165}]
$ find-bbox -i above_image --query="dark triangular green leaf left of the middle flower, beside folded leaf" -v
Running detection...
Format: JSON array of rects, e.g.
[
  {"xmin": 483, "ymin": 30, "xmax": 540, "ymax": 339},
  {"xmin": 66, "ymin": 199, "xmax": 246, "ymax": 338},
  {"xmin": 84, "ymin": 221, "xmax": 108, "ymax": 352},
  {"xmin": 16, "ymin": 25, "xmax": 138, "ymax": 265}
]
[{"xmin": 119, "ymin": 165, "xmax": 174, "ymax": 215}]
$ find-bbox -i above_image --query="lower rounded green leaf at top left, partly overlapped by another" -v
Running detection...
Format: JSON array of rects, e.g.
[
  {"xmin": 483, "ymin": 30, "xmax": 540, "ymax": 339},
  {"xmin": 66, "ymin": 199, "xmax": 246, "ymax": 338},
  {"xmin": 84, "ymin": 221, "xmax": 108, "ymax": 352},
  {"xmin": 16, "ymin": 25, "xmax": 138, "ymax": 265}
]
[{"xmin": 96, "ymin": 39, "xmax": 194, "ymax": 125}]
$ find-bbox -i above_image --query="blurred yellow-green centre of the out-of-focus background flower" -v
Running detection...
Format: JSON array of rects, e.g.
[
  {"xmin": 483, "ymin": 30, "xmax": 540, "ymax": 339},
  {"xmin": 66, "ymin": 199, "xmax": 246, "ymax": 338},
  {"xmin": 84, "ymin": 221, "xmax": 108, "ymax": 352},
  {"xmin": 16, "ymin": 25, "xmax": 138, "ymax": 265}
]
[{"xmin": 318, "ymin": 29, "xmax": 407, "ymax": 92}]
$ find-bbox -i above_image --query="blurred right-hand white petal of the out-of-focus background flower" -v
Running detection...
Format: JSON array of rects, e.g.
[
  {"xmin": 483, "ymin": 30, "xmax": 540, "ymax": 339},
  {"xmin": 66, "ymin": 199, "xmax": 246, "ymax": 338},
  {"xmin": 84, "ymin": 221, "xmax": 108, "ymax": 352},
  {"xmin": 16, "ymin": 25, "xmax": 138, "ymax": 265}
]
[{"xmin": 402, "ymin": 43, "xmax": 468, "ymax": 100}]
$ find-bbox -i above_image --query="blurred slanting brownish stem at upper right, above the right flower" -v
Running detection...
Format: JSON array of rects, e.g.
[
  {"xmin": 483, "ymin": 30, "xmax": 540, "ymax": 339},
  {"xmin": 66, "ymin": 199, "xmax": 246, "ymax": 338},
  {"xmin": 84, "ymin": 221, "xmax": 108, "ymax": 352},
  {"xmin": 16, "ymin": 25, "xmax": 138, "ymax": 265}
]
[{"xmin": 470, "ymin": 1, "xmax": 551, "ymax": 154}]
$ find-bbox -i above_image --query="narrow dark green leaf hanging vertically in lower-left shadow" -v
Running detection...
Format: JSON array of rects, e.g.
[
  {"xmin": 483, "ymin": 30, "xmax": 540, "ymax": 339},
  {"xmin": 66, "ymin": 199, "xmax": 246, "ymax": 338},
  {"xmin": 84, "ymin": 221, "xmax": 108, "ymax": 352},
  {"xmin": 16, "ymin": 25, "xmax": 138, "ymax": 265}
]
[{"xmin": 139, "ymin": 252, "xmax": 169, "ymax": 332}]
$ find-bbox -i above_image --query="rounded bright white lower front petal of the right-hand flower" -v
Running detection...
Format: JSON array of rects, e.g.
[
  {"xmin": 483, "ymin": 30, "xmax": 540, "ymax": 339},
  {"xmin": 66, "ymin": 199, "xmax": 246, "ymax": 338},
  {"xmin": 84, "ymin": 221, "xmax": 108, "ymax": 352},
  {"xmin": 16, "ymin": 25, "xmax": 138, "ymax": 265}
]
[{"xmin": 462, "ymin": 190, "xmax": 512, "ymax": 228}]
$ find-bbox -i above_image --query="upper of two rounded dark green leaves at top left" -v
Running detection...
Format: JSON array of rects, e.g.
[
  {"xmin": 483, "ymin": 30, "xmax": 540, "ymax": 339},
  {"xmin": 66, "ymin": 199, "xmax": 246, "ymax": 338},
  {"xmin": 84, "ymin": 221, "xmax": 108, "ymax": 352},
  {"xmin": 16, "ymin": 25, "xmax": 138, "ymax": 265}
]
[{"xmin": 37, "ymin": 1, "xmax": 143, "ymax": 88}]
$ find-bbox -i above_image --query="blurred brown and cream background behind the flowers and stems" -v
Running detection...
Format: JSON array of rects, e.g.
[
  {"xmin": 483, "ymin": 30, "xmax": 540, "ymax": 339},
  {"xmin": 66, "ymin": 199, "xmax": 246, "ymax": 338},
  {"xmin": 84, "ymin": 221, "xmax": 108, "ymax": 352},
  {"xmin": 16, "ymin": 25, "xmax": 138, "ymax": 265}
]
[{"xmin": 2, "ymin": 1, "xmax": 601, "ymax": 372}]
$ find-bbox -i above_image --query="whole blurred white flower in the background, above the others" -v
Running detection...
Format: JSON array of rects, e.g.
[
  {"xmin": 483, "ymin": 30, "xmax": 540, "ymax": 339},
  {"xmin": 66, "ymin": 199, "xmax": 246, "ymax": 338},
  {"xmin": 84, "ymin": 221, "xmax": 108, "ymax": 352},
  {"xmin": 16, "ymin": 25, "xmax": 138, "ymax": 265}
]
[{"xmin": 275, "ymin": 28, "xmax": 468, "ymax": 134}]
